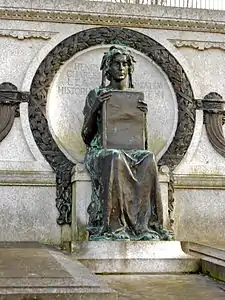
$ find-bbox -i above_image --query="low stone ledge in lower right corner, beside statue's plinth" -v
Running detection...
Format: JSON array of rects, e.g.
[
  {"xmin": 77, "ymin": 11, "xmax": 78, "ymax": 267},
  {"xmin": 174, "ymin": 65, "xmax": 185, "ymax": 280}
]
[{"xmin": 182, "ymin": 242, "xmax": 225, "ymax": 282}]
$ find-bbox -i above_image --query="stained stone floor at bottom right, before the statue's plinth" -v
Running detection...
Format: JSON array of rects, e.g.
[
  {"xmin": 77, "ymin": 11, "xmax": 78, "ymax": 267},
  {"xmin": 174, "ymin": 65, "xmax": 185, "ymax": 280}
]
[{"xmin": 100, "ymin": 274, "xmax": 225, "ymax": 300}]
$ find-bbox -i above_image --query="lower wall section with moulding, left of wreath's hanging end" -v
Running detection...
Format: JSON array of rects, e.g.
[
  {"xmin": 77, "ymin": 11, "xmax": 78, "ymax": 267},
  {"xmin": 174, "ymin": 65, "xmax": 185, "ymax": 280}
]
[{"xmin": 0, "ymin": 183, "xmax": 61, "ymax": 245}]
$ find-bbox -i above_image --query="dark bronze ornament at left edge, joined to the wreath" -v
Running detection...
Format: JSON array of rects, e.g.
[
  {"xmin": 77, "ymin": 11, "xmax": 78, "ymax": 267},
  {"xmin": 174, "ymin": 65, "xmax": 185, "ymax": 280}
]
[{"xmin": 0, "ymin": 82, "xmax": 28, "ymax": 142}]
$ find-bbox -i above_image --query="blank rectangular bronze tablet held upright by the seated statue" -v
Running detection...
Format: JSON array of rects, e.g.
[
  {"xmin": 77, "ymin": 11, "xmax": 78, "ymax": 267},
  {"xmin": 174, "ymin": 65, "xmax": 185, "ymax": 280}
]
[{"xmin": 102, "ymin": 91, "xmax": 145, "ymax": 150}]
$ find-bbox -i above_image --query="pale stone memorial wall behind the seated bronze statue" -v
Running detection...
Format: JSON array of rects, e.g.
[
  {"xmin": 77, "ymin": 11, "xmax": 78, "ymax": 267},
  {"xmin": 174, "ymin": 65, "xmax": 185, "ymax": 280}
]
[{"xmin": 0, "ymin": 0, "xmax": 225, "ymax": 244}]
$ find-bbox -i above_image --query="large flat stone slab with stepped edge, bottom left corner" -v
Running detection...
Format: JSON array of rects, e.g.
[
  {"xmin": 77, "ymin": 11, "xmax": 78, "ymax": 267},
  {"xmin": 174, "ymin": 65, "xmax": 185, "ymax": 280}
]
[{"xmin": 0, "ymin": 243, "xmax": 117, "ymax": 300}]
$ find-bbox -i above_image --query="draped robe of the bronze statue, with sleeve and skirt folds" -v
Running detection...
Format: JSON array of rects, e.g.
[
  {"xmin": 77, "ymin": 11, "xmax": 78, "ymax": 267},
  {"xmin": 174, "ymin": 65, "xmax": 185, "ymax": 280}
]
[{"xmin": 82, "ymin": 88, "xmax": 162, "ymax": 240}]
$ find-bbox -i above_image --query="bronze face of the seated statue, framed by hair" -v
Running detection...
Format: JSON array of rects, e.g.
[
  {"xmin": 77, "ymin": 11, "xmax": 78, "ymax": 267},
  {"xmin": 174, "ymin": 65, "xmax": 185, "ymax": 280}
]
[{"xmin": 110, "ymin": 54, "xmax": 128, "ymax": 81}]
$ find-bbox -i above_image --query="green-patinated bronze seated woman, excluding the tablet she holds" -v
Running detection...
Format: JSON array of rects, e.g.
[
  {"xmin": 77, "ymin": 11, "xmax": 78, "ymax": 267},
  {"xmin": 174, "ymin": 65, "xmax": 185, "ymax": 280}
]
[{"xmin": 82, "ymin": 46, "xmax": 169, "ymax": 240}]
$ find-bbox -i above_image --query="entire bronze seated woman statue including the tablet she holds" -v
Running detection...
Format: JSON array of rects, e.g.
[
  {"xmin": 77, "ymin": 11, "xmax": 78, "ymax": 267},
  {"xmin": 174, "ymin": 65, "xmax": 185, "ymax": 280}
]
[{"xmin": 82, "ymin": 46, "xmax": 171, "ymax": 240}]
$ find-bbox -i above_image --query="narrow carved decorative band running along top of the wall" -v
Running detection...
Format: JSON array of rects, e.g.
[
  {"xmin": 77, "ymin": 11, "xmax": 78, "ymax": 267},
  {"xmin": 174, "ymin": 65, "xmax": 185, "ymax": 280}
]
[{"xmin": 0, "ymin": 8, "xmax": 225, "ymax": 33}]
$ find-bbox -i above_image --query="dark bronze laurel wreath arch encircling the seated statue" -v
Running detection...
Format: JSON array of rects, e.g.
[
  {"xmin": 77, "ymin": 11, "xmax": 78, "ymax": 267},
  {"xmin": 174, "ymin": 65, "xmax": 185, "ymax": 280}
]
[{"xmin": 29, "ymin": 27, "xmax": 195, "ymax": 225}]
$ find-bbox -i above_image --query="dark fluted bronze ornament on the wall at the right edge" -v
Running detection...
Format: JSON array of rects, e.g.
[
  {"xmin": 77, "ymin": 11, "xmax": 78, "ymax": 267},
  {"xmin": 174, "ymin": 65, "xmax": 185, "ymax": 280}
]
[{"xmin": 202, "ymin": 92, "xmax": 225, "ymax": 157}]
